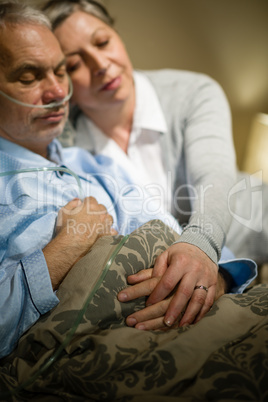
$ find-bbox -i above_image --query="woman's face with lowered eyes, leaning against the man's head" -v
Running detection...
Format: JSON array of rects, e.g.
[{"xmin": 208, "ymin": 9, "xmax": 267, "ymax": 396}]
[{"xmin": 55, "ymin": 11, "xmax": 134, "ymax": 115}]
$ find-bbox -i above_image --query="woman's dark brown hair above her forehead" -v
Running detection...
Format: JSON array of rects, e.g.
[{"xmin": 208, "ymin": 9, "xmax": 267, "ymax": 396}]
[{"xmin": 42, "ymin": 0, "xmax": 114, "ymax": 30}]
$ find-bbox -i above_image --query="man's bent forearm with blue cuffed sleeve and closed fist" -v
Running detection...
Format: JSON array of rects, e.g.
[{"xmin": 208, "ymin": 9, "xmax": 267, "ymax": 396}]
[{"xmin": 0, "ymin": 197, "xmax": 115, "ymax": 358}]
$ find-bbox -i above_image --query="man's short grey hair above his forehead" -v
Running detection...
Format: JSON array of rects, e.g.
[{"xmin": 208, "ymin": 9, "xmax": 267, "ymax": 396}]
[{"xmin": 0, "ymin": 0, "xmax": 51, "ymax": 30}]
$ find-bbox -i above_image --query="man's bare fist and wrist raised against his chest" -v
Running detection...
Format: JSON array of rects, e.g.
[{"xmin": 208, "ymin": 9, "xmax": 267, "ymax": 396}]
[{"xmin": 43, "ymin": 197, "xmax": 116, "ymax": 290}]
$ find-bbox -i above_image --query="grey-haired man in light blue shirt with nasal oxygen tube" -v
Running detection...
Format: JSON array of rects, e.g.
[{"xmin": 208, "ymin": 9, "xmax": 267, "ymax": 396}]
[{"xmin": 0, "ymin": 1, "xmax": 256, "ymax": 357}]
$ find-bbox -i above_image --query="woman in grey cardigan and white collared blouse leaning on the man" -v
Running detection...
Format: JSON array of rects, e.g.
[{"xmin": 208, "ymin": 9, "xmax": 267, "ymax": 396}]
[{"xmin": 40, "ymin": 0, "xmax": 267, "ymax": 325}]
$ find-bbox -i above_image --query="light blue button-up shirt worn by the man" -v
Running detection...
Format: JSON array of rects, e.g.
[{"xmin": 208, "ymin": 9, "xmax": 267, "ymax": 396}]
[{"xmin": 0, "ymin": 138, "xmax": 256, "ymax": 357}]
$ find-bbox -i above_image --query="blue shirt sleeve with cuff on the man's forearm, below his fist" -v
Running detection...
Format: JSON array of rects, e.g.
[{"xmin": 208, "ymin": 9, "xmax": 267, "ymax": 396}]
[{"xmin": 0, "ymin": 249, "xmax": 59, "ymax": 358}]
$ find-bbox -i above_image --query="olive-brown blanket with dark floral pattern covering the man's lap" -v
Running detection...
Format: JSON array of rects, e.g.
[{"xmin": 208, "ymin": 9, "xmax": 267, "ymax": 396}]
[{"xmin": 0, "ymin": 221, "xmax": 268, "ymax": 402}]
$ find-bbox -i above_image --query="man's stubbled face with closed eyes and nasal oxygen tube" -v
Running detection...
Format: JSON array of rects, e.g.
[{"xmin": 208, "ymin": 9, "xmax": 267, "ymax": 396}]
[{"xmin": 0, "ymin": 25, "xmax": 68, "ymax": 154}]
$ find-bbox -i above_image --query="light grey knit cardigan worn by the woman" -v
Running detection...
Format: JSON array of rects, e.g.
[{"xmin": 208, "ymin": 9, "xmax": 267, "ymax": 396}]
[{"xmin": 64, "ymin": 70, "xmax": 236, "ymax": 262}]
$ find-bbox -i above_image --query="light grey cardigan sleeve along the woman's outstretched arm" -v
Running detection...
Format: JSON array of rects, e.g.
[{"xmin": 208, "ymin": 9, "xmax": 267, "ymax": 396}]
[{"xmin": 176, "ymin": 75, "xmax": 236, "ymax": 263}]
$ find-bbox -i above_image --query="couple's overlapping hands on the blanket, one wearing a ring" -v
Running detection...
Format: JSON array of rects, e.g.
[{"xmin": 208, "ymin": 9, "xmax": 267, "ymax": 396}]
[{"xmin": 118, "ymin": 243, "xmax": 220, "ymax": 330}]
